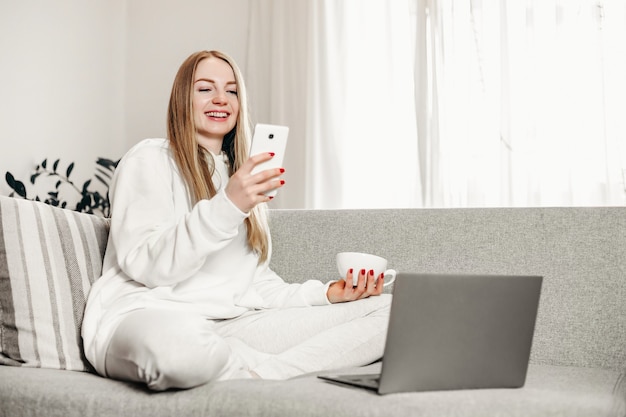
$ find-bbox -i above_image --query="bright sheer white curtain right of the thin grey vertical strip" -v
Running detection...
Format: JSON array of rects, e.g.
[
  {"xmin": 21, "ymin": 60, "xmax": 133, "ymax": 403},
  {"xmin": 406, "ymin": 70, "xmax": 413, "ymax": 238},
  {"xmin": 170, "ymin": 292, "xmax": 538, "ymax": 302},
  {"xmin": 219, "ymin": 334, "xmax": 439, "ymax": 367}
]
[{"xmin": 421, "ymin": 0, "xmax": 626, "ymax": 207}]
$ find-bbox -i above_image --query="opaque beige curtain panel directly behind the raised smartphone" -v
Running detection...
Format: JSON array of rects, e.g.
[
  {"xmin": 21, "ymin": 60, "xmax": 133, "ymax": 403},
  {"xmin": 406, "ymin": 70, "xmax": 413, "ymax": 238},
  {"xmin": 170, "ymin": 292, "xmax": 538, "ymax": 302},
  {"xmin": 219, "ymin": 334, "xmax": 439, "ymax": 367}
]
[{"xmin": 242, "ymin": 0, "xmax": 312, "ymax": 208}]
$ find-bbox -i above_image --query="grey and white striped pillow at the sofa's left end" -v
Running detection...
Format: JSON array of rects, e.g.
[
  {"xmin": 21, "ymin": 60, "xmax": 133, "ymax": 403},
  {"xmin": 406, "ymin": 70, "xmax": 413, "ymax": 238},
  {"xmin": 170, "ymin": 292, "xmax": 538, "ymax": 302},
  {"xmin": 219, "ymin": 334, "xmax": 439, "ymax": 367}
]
[{"xmin": 0, "ymin": 196, "xmax": 109, "ymax": 371}]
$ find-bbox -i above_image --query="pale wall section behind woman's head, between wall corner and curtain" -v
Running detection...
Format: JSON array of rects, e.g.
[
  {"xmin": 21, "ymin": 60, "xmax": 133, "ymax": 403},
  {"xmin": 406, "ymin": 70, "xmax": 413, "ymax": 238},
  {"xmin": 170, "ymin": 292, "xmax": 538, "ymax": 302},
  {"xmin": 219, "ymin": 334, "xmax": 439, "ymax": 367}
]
[{"xmin": 125, "ymin": 0, "xmax": 250, "ymax": 146}]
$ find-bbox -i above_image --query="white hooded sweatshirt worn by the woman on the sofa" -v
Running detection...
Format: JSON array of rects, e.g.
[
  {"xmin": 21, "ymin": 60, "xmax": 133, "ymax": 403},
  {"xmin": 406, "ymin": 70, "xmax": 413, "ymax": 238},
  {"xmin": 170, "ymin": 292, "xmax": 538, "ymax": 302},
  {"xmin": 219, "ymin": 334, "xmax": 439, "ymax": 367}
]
[{"xmin": 82, "ymin": 139, "xmax": 330, "ymax": 375}]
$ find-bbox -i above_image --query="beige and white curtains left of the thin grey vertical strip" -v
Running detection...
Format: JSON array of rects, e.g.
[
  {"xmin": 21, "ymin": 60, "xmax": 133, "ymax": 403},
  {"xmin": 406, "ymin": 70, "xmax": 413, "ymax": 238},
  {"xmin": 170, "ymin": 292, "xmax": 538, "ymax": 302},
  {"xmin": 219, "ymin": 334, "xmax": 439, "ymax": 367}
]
[{"xmin": 246, "ymin": 0, "xmax": 421, "ymax": 208}]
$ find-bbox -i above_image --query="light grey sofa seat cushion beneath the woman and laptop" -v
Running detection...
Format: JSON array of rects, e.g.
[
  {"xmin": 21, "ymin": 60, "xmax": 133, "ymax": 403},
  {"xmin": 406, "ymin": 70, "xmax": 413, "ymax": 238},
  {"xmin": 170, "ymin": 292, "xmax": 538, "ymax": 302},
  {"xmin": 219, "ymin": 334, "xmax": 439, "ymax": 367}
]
[{"xmin": 0, "ymin": 364, "xmax": 626, "ymax": 417}]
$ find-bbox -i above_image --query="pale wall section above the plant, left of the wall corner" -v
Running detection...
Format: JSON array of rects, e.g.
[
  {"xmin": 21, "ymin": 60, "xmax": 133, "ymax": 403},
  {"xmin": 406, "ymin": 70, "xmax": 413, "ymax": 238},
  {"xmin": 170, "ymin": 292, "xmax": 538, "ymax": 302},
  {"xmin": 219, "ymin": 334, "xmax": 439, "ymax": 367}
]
[{"xmin": 0, "ymin": 0, "xmax": 125, "ymax": 200}]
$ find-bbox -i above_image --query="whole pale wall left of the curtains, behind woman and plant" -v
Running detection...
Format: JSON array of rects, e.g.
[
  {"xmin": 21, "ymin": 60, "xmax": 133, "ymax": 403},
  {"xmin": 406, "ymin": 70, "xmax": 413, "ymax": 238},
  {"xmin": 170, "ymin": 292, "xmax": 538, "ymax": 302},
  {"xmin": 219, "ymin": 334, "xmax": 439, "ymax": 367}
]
[{"xmin": 0, "ymin": 0, "xmax": 250, "ymax": 203}]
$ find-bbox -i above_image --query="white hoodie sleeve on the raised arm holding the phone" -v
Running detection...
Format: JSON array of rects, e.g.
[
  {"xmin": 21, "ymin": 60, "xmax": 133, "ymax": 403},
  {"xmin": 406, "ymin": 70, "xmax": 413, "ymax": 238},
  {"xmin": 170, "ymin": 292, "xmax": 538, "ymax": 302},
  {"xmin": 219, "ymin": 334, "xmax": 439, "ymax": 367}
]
[{"xmin": 105, "ymin": 142, "xmax": 247, "ymax": 287}]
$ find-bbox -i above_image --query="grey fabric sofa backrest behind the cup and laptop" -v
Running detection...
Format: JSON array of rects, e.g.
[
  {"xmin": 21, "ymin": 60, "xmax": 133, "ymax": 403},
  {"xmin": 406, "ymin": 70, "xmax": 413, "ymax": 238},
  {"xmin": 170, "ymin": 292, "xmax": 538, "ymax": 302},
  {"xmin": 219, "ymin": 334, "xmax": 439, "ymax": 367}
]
[{"xmin": 270, "ymin": 207, "xmax": 626, "ymax": 369}]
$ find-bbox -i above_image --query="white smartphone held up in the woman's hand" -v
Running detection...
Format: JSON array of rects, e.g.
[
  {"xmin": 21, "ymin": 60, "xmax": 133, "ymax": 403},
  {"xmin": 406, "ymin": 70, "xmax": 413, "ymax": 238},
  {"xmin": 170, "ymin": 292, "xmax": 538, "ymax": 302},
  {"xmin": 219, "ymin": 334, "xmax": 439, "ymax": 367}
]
[{"xmin": 249, "ymin": 123, "xmax": 289, "ymax": 197}]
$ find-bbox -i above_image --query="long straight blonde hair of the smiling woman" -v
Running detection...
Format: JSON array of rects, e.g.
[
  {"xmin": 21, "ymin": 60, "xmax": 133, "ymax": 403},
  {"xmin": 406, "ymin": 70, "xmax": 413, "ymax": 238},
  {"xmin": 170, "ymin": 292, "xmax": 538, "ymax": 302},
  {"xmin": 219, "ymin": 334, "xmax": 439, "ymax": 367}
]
[{"xmin": 167, "ymin": 51, "xmax": 269, "ymax": 263}]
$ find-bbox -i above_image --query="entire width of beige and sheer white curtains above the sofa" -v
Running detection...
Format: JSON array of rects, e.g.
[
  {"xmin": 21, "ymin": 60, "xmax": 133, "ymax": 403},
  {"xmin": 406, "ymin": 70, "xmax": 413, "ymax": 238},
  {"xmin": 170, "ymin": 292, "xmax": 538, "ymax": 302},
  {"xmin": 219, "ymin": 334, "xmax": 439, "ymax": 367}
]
[{"xmin": 246, "ymin": 0, "xmax": 626, "ymax": 208}]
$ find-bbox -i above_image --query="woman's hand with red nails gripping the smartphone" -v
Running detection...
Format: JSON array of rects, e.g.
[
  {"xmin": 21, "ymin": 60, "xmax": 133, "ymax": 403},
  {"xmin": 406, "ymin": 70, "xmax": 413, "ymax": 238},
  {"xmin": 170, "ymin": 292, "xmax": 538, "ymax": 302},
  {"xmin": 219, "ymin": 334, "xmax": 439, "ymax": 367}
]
[{"xmin": 225, "ymin": 153, "xmax": 285, "ymax": 213}]
